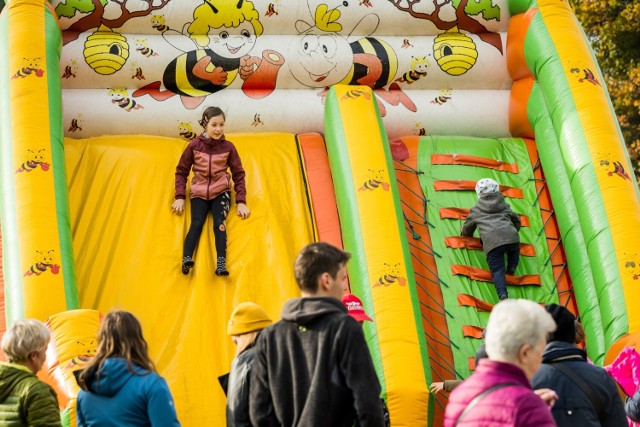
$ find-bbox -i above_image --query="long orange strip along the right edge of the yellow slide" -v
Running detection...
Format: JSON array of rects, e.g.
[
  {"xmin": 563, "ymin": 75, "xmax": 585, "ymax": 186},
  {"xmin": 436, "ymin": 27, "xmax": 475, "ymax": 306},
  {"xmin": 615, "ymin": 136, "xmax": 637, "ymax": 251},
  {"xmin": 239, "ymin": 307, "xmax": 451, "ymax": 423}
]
[{"xmin": 298, "ymin": 133, "xmax": 343, "ymax": 248}]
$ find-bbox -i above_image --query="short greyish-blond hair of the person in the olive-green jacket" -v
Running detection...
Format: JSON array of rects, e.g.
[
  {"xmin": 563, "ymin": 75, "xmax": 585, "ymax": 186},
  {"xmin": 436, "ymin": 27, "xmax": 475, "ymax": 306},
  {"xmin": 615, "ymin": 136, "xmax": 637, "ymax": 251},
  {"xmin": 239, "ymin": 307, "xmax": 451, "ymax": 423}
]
[{"xmin": 1, "ymin": 319, "xmax": 51, "ymax": 362}]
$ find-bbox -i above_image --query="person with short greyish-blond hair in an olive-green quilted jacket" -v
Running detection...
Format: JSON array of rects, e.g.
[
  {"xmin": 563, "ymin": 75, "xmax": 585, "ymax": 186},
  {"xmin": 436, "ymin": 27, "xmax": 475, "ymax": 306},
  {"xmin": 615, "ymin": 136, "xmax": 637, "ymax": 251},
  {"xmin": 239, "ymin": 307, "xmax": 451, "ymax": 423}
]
[{"xmin": 0, "ymin": 319, "xmax": 60, "ymax": 427}]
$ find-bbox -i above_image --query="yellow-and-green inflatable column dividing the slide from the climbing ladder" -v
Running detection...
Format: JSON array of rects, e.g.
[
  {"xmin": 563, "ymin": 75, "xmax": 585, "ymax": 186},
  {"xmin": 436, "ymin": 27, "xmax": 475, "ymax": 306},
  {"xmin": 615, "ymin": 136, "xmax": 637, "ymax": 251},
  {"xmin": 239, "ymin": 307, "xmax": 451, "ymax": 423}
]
[{"xmin": 325, "ymin": 85, "xmax": 433, "ymax": 426}]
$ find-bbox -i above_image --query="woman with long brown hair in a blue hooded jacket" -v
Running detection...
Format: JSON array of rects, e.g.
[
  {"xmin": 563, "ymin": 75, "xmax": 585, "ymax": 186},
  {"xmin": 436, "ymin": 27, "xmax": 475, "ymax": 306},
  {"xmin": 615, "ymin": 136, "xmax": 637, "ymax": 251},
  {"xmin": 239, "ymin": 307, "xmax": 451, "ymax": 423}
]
[{"xmin": 76, "ymin": 311, "xmax": 180, "ymax": 427}]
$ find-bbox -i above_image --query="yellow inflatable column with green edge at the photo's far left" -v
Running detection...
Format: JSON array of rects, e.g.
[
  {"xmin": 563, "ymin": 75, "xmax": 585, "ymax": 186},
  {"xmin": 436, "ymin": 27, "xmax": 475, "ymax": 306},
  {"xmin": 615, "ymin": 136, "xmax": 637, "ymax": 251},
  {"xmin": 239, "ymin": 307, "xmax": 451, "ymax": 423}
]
[{"xmin": 0, "ymin": 0, "xmax": 77, "ymax": 322}]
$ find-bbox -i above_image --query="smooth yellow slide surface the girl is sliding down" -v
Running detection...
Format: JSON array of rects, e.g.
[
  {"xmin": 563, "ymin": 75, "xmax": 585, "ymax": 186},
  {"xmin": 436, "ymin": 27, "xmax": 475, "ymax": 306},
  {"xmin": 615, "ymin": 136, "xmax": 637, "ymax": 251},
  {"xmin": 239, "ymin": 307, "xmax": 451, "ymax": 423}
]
[{"xmin": 65, "ymin": 133, "xmax": 313, "ymax": 426}]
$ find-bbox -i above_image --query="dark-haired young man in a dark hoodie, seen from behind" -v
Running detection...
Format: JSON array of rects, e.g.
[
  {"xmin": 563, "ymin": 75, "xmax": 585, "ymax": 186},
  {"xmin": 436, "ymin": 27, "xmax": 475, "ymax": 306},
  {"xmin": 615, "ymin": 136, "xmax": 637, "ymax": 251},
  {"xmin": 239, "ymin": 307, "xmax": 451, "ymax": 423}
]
[{"xmin": 249, "ymin": 243, "xmax": 385, "ymax": 427}]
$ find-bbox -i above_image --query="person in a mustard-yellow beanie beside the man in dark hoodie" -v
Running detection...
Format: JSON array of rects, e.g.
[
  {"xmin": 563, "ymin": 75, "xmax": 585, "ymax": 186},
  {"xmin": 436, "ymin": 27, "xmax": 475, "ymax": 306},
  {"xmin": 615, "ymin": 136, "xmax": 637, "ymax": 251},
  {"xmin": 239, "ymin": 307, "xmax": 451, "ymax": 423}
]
[{"xmin": 227, "ymin": 302, "xmax": 273, "ymax": 427}]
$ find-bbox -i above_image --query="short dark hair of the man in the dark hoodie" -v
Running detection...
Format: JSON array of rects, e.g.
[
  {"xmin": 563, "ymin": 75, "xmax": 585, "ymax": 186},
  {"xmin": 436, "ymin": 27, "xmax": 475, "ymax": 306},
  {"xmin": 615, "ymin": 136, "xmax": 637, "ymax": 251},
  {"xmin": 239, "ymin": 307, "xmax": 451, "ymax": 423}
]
[{"xmin": 293, "ymin": 242, "xmax": 351, "ymax": 294}]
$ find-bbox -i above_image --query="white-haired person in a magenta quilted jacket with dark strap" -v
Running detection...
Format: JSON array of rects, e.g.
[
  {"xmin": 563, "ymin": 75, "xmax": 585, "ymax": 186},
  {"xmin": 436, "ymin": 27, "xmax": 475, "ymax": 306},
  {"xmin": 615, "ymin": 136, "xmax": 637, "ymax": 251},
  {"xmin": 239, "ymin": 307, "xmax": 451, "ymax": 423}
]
[{"xmin": 444, "ymin": 299, "xmax": 556, "ymax": 427}]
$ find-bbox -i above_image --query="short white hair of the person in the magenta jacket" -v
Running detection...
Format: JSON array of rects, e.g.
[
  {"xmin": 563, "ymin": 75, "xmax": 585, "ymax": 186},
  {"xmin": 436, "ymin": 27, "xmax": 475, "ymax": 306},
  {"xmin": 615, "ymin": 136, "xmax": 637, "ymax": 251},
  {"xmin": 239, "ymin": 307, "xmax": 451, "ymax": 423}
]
[{"xmin": 485, "ymin": 299, "xmax": 556, "ymax": 361}]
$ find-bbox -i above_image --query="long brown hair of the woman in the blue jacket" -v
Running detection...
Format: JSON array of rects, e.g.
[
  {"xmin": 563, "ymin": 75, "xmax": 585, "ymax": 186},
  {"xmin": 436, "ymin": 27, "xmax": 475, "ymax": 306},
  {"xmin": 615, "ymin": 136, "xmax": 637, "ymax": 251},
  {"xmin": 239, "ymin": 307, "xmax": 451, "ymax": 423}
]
[{"xmin": 78, "ymin": 311, "xmax": 156, "ymax": 391}]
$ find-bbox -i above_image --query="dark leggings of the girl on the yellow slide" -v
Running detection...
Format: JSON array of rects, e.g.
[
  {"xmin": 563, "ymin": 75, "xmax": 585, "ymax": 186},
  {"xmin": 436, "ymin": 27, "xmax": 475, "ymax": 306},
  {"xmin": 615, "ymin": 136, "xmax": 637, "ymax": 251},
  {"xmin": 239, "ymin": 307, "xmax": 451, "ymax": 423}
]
[{"xmin": 183, "ymin": 191, "xmax": 231, "ymax": 258}]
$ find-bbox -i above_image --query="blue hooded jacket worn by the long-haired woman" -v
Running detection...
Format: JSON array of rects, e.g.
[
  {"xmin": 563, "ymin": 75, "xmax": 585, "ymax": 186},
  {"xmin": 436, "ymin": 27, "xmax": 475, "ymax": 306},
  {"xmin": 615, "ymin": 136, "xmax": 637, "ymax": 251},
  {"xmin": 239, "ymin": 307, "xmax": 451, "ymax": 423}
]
[{"xmin": 76, "ymin": 358, "xmax": 180, "ymax": 427}]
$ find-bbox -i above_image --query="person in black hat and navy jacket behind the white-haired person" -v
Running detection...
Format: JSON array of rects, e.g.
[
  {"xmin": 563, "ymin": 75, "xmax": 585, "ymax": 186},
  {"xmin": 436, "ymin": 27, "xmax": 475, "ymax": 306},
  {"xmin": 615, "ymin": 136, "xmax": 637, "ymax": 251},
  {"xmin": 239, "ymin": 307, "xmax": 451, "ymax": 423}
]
[{"xmin": 531, "ymin": 304, "xmax": 627, "ymax": 427}]
